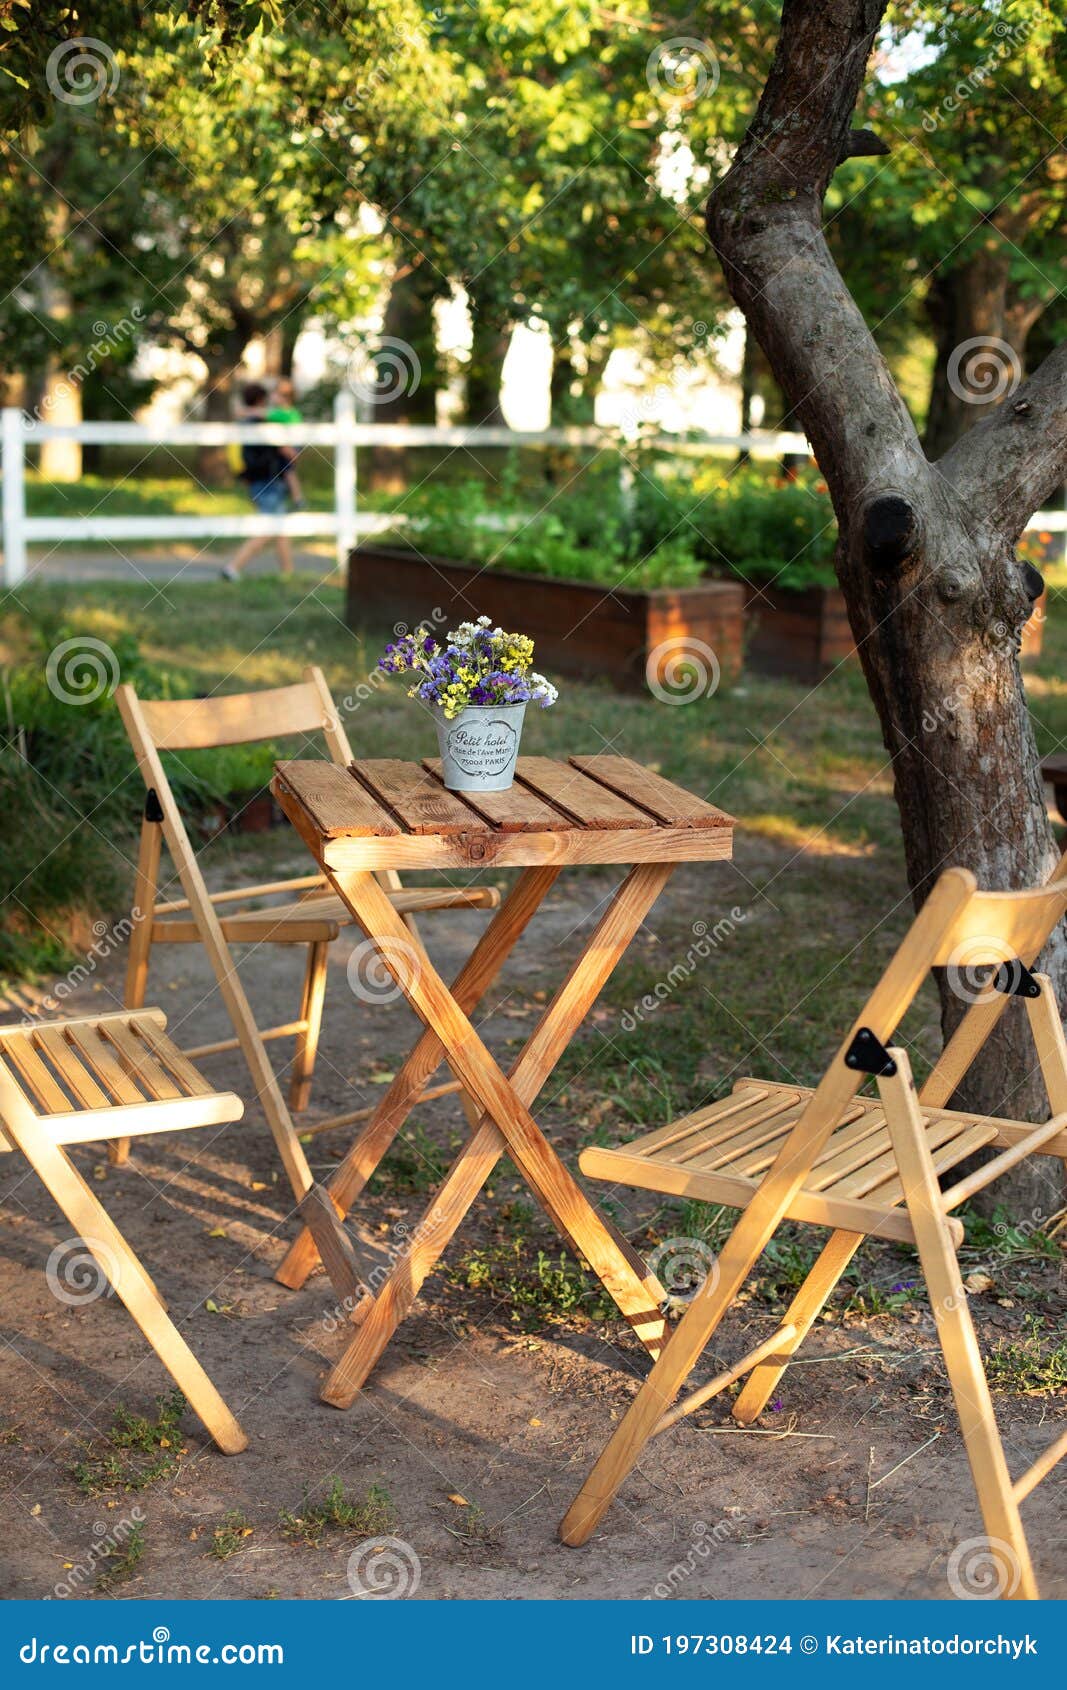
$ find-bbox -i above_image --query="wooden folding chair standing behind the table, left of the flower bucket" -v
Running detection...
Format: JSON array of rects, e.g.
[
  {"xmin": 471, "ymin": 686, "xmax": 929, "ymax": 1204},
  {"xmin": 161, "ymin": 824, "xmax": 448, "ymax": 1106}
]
[{"xmin": 110, "ymin": 668, "xmax": 499, "ymax": 1202}]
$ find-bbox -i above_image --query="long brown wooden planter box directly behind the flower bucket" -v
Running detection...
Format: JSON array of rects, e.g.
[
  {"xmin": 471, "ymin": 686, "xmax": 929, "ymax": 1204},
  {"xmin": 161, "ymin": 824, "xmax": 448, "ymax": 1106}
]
[{"xmin": 347, "ymin": 546, "xmax": 746, "ymax": 688}]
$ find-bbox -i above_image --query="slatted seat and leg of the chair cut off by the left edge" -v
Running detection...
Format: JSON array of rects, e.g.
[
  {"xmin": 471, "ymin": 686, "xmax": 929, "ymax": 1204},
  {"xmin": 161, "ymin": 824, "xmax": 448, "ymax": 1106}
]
[{"xmin": 0, "ymin": 1009, "xmax": 249, "ymax": 1455}]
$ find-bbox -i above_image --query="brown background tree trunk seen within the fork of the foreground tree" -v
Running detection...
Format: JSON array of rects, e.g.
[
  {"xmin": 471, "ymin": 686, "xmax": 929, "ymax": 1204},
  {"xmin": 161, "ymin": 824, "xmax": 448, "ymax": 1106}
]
[{"xmin": 923, "ymin": 240, "xmax": 1043, "ymax": 460}]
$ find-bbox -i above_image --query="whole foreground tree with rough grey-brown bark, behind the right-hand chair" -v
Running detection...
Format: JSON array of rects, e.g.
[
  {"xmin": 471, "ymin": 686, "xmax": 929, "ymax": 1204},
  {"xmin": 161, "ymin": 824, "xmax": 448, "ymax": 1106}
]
[{"xmin": 709, "ymin": 0, "xmax": 1067, "ymax": 1218}]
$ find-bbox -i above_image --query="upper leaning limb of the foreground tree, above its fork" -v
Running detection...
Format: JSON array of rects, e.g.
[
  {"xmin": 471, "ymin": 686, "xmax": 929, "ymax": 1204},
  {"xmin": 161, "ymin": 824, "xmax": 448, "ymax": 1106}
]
[{"xmin": 707, "ymin": 0, "xmax": 928, "ymax": 517}]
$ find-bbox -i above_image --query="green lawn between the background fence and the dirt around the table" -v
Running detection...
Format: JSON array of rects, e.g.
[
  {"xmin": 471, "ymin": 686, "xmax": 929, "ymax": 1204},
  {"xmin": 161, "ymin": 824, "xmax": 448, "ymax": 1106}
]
[{"xmin": 0, "ymin": 566, "xmax": 1067, "ymax": 1325}]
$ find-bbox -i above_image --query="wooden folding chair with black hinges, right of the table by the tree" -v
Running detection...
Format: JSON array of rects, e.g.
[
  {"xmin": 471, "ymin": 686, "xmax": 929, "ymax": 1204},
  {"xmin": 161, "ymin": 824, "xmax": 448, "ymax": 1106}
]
[{"xmin": 561, "ymin": 853, "xmax": 1067, "ymax": 1597}]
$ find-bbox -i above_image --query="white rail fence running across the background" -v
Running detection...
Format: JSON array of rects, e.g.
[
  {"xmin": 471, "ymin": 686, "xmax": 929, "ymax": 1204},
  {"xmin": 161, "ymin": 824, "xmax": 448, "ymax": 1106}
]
[{"xmin": 0, "ymin": 392, "xmax": 1067, "ymax": 586}]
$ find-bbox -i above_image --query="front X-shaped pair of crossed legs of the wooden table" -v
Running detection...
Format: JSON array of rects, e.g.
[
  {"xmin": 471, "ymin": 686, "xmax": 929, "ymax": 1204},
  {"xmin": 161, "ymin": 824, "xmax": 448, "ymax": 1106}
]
[{"xmin": 323, "ymin": 864, "xmax": 673, "ymax": 1408}]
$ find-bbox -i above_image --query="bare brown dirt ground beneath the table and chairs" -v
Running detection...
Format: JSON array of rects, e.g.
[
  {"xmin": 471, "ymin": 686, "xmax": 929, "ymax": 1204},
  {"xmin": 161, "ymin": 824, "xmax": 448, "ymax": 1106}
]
[{"xmin": 0, "ymin": 835, "xmax": 1067, "ymax": 1600}]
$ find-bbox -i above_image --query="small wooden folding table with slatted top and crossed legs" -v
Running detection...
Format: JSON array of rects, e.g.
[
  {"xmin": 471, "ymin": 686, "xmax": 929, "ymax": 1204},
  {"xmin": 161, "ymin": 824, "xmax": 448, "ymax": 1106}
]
[{"xmin": 274, "ymin": 755, "xmax": 734, "ymax": 1408}]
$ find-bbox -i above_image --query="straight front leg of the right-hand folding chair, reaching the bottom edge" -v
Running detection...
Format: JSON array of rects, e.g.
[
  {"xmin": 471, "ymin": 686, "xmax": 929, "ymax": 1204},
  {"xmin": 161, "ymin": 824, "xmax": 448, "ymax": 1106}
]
[{"xmin": 878, "ymin": 1049, "xmax": 1038, "ymax": 1599}]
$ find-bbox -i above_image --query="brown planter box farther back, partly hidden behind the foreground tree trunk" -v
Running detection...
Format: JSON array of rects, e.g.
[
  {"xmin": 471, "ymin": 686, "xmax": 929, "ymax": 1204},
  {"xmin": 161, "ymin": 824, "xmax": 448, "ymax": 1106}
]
[{"xmin": 746, "ymin": 586, "xmax": 1045, "ymax": 681}]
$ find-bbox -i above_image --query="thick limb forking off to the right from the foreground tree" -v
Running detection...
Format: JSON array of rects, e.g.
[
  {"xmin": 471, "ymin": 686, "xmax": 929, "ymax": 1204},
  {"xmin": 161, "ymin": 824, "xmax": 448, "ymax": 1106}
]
[{"xmin": 937, "ymin": 341, "xmax": 1067, "ymax": 544}]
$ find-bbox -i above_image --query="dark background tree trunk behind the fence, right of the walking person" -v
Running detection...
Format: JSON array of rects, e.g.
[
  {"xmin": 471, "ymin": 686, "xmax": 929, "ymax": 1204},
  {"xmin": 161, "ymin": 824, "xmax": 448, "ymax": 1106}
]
[{"xmin": 370, "ymin": 269, "xmax": 440, "ymax": 493}]
